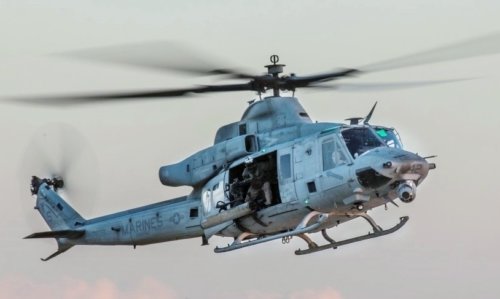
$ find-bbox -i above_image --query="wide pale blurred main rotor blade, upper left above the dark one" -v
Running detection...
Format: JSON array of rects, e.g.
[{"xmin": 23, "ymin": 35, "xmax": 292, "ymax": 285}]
[{"xmin": 60, "ymin": 41, "xmax": 254, "ymax": 78}]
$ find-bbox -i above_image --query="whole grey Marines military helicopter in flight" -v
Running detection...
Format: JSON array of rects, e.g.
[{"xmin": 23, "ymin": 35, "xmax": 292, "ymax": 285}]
[{"xmin": 23, "ymin": 34, "xmax": 500, "ymax": 261}]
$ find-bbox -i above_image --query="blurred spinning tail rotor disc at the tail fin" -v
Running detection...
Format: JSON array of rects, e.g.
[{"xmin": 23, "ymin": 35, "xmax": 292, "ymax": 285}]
[{"xmin": 19, "ymin": 123, "xmax": 99, "ymax": 226}]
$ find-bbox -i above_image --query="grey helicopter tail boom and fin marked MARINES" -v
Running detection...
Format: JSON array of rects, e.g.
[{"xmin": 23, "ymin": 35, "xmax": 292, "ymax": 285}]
[{"xmin": 25, "ymin": 182, "xmax": 203, "ymax": 260}]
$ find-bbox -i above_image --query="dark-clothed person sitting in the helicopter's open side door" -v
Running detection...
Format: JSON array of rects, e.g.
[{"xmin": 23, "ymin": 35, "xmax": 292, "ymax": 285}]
[{"xmin": 243, "ymin": 159, "xmax": 272, "ymax": 206}]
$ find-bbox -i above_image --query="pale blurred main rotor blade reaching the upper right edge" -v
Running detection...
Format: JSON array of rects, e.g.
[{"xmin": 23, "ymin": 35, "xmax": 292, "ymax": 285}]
[{"xmin": 358, "ymin": 32, "xmax": 500, "ymax": 72}]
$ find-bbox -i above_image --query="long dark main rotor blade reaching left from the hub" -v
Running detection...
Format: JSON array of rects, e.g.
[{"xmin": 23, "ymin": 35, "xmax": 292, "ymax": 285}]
[{"xmin": 11, "ymin": 83, "xmax": 255, "ymax": 105}]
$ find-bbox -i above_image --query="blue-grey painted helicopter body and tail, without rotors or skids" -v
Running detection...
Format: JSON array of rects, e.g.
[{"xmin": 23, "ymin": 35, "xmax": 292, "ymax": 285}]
[{"xmin": 25, "ymin": 97, "xmax": 431, "ymax": 257}]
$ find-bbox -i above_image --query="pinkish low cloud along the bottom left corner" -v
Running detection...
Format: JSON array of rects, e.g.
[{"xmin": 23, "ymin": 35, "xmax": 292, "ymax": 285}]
[{"xmin": 0, "ymin": 276, "xmax": 179, "ymax": 299}]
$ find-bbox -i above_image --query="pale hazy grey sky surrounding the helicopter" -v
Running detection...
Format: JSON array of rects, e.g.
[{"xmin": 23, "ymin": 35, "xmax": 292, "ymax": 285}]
[{"xmin": 0, "ymin": 0, "xmax": 500, "ymax": 299}]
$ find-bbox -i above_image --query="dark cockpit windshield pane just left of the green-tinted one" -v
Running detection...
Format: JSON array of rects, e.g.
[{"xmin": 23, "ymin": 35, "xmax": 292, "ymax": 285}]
[{"xmin": 342, "ymin": 127, "xmax": 384, "ymax": 158}]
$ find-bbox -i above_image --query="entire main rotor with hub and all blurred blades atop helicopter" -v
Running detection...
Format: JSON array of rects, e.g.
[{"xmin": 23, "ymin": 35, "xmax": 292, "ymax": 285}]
[{"xmin": 8, "ymin": 33, "xmax": 500, "ymax": 106}]
